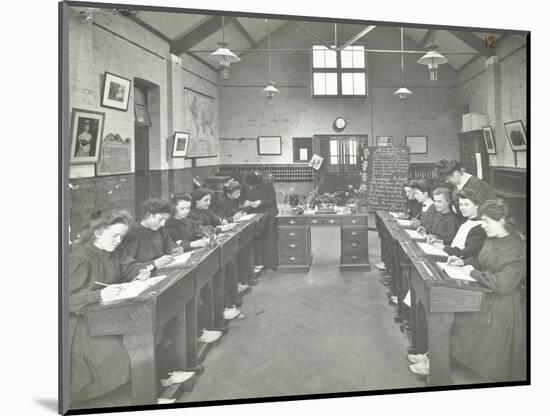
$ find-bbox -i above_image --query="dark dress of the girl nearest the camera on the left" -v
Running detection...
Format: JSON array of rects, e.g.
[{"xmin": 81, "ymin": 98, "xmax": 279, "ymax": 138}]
[{"xmin": 68, "ymin": 244, "xmax": 144, "ymax": 403}]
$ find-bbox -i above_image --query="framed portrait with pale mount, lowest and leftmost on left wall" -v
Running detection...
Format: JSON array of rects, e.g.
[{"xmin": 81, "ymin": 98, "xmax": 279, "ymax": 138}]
[{"xmin": 71, "ymin": 108, "xmax": 105, "ymax": 164}]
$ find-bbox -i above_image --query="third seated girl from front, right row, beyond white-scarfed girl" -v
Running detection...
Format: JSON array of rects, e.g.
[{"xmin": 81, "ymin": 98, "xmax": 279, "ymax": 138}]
[{"xmin": 426, "ymin": 188, "xmax": 458, "ymax": 244}]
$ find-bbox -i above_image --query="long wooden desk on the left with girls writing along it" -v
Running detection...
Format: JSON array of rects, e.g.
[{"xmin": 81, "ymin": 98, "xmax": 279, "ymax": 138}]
[{"xmin": 80, "ymin": 214, "xmax": 264, "ymax": 404}]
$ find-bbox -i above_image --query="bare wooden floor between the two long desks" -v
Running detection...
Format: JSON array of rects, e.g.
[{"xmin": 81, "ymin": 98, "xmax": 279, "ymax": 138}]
[{"xmin": 181, "ymin": 227, "xmax": 425, "ymax": 402}]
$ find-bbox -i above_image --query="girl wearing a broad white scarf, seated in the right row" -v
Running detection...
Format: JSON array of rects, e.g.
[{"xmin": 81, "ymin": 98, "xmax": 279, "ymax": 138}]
[{"xmin": 434, "ymin": 189, "xmax": 485, "ymax": 259}]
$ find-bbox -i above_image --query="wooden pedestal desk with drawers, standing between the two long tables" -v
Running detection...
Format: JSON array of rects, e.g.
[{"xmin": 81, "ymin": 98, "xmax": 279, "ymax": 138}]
[{"xmin": 277, "ymin": 214, "xmax": 370, "ymax": 272}]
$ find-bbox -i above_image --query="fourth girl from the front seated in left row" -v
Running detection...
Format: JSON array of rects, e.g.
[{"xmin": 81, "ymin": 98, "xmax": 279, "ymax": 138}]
[{"xmin": 189, "ymin": 187, "xmax": 241, "ymax": 320}]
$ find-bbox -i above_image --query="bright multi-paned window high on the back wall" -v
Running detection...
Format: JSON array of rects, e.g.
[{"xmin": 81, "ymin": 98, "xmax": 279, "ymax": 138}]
[{"xmin": 312, "ymin": 45, "xmax": 367, "ymax": 97}]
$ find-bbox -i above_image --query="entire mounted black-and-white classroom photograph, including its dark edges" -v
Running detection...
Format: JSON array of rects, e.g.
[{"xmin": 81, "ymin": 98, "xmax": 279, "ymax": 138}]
[{"xmin": 58, "ymin": 1, "xmax": 531, "ymax": 414}]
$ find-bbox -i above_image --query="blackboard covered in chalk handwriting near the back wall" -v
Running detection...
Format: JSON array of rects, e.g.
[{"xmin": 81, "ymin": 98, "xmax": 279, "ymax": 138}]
[{"xmin": 365, "ymin": 146, "xmax": 410, "ymax": 211}]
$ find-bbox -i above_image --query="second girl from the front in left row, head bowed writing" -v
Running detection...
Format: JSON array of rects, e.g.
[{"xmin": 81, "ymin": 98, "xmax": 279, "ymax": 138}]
[{"xmin": 120, "ymin": 198, "xmax": 178, "ymax": 269}]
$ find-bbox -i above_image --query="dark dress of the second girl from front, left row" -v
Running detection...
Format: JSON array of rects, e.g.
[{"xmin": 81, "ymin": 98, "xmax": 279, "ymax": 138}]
[{"xmin": 120, "ymin": 224, "xmax": 175, "ymax": 265}]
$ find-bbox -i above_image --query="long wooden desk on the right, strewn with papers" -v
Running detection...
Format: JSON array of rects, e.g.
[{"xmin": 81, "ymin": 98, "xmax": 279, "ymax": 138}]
[{"xmin": 376, "ymin": 211, "xmax": 491, "ymax": 385}]
